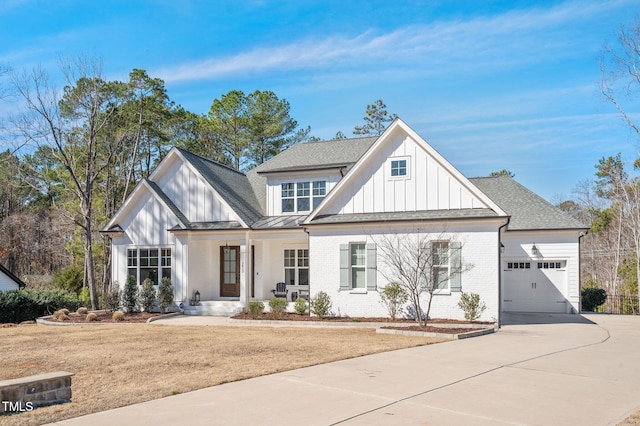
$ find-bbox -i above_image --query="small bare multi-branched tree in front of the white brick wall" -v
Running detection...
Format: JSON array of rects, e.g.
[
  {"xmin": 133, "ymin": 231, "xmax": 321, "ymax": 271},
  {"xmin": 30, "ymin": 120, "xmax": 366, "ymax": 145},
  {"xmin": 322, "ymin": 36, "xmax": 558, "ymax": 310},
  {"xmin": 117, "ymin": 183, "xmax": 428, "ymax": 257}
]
[{"xmin": 372, "ymin": 229, "xmax": 473, "ymax": 327}]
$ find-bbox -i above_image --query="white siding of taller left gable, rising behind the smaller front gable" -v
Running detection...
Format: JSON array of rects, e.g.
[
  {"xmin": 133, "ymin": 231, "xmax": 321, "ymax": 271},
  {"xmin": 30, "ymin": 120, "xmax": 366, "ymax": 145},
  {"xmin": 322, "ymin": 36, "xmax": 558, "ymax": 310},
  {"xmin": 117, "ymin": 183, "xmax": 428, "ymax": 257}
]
[{"xmin": 154, "ymin": 155, "xmax": 238, "ymax": 222}]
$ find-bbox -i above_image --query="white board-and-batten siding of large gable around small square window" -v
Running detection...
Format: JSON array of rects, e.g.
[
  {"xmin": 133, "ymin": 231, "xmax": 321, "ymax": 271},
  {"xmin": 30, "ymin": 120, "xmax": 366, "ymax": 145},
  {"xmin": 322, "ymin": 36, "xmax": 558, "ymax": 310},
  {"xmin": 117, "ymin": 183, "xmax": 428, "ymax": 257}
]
[{"xmin": 324, "ymin": 132, "xmax": 487, "ymax": 214}]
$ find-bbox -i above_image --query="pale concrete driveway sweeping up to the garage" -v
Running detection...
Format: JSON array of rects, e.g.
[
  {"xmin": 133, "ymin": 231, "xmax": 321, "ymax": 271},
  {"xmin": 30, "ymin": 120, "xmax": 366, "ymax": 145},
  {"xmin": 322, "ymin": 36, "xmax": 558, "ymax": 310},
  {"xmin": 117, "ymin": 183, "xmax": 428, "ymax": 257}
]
[{"xmin": 48, "ymin": 315, "xmax": 640, "ymax": 425}]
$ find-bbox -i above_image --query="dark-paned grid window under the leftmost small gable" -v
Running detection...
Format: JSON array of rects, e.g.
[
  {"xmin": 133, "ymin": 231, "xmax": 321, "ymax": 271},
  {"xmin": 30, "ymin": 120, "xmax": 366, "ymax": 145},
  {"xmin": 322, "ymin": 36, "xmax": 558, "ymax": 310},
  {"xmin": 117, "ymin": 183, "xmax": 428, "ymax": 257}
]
[{"xmin": 127, "ymin": 247, "xmax": 171, "ymax": 285}]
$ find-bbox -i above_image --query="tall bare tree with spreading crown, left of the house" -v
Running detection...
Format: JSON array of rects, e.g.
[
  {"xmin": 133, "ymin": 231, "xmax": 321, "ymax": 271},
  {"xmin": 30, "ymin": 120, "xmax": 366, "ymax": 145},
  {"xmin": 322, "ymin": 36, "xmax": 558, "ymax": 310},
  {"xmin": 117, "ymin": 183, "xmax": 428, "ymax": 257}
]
[{"xmin": 14, "ymin": 58, "xmax": 123, "ymax": 309}]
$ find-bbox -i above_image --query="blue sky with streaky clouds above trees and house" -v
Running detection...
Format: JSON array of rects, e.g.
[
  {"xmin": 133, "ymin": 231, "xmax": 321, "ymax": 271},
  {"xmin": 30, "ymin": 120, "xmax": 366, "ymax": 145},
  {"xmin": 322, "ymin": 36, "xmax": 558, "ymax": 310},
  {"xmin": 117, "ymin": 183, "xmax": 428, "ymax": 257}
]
[{"xmin": 0, "ymin": 0, "xmax": 640, "ymax": 201}]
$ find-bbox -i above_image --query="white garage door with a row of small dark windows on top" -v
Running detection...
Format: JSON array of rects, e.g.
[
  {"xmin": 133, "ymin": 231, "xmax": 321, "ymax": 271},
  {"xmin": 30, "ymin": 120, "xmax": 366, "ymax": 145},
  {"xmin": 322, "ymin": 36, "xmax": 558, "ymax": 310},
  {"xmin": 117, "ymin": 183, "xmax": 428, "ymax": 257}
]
[{"xmin": 502, "ymin": 261, "xmax": 568, "ymax": 313}]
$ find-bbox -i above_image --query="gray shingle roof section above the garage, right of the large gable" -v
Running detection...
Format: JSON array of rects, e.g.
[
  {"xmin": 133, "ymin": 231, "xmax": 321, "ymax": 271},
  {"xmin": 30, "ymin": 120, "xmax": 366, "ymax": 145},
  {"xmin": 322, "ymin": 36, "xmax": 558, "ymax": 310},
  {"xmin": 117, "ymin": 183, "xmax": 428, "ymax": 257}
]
[{"xmin": 469, "ymin": 176, "xmax": 588, "ymax": 231}]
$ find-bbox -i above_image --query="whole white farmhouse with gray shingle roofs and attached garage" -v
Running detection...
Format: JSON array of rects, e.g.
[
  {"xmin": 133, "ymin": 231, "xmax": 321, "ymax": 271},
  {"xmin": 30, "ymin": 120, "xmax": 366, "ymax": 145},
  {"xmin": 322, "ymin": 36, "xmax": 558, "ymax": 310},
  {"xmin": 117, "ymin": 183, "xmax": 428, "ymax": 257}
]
[{"xmin": 103, "ymin": 119, "xmax": 586, "ymax": 320}]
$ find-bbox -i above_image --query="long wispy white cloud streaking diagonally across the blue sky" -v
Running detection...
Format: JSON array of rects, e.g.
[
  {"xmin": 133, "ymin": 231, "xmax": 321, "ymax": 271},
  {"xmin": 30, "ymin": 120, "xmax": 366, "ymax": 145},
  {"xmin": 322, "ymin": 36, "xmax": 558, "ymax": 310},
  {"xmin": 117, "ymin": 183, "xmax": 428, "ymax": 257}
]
[{"xmin": 154, "ymin": 2, "xmax": 619, "ymax": 82}]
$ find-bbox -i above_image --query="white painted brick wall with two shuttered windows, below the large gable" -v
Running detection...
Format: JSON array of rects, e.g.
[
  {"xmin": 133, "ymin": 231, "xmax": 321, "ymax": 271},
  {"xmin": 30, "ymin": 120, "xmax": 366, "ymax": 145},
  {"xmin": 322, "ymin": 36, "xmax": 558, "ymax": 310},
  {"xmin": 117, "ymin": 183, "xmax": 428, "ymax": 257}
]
[{"xmin": 309, "ymin": 224, "xmax": 499, "ymax": 321}]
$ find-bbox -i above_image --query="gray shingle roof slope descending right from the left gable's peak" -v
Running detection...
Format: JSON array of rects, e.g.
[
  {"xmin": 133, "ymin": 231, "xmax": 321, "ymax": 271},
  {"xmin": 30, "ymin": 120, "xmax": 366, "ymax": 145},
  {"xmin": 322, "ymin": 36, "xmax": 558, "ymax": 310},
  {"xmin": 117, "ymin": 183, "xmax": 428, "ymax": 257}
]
[{"xmin": 178, "ymin": 148, "xmax": 263, "ymax": 226}]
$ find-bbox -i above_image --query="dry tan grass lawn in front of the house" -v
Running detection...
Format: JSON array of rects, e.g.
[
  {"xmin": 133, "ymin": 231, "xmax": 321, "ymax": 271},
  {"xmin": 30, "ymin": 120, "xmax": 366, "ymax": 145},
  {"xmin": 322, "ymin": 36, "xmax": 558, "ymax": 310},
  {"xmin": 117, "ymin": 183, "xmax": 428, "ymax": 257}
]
[{"xmin": 0, "ymin": 324, "xmax": 440, "ymax": 425}]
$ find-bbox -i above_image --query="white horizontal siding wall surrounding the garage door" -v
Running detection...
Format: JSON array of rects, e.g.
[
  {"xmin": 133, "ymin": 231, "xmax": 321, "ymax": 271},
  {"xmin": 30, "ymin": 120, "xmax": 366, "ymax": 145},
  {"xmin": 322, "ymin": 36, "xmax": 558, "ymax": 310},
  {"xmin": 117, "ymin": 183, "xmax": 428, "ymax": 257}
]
[{"xmin": 502, "ymin": 230, "xmax": 580, "ymax": 313}]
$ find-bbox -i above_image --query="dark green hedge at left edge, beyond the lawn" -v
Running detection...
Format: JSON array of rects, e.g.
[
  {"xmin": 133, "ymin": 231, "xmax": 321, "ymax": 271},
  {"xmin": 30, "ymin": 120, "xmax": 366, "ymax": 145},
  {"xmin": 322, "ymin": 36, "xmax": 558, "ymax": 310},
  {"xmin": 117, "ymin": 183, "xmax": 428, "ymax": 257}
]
[{"xmin": 0, "ymin": 289, "xmax": 82, "ymax": 324}]
